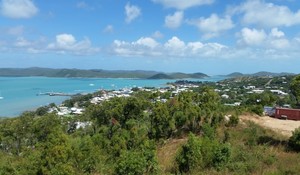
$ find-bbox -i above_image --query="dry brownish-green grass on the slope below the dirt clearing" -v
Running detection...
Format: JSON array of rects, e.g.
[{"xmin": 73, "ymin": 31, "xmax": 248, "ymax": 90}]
[{"xmin": 157, "ymin": 122, "xmax": 300, "ymax": 175}]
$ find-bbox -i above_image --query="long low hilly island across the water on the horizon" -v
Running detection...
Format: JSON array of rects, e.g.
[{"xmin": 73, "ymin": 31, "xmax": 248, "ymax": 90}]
[{"xmin": 0, "ymin": 67, "xmax": 209, "ymax": 79}]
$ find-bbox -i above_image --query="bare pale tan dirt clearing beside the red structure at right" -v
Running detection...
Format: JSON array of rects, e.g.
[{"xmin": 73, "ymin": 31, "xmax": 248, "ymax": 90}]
[{"xmin": 240, "ymin": 115, "xmax": 300, "ymax": 137}]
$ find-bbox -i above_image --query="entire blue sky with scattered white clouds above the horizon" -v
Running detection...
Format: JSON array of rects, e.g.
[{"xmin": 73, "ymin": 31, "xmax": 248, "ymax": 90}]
[{"xmin": 0, "ymin": 0, "xmax": 300, "ymax": 75}]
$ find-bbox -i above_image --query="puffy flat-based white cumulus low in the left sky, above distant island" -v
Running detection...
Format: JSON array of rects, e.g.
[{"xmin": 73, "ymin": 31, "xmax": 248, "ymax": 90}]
[{"xmin": 46, "ymin": 34, "xmax": 99, "ymax": 55}]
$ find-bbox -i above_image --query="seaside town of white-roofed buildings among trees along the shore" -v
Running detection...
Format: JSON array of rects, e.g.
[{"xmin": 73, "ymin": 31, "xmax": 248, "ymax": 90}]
[{"xmin": 48, "ymin": 75, "xmax": 300, "ymax": 120}]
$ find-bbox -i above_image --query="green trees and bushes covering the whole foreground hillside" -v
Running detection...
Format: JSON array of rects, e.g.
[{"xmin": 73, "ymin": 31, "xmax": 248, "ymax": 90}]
[{"xmin": 0, "ymin": 75, "xmax": 300, "ymax": 175}]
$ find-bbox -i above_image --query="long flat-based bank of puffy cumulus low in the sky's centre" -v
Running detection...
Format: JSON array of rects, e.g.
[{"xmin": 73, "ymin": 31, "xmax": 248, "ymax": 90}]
[{"xmin": 111, "ymin": 36, "xmax": 227, "ymax": 58}]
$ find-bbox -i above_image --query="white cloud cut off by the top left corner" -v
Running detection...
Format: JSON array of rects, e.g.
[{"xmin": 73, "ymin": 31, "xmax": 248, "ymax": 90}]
[{"xmin": 0, "ymin": 0, "xmax": 38, "ymax": 19}]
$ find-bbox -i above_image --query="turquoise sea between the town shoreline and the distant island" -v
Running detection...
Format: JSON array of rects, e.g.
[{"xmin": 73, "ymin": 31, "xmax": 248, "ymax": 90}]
[{"xmin": 0, "ymin": 76, "xmax": 226, "ymax": 117}]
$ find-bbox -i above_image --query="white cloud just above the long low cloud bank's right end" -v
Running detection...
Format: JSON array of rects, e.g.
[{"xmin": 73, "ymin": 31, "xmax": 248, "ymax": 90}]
[{"xmin": 188, "ymin": 14, "xmax": 234, "ymax": 39}]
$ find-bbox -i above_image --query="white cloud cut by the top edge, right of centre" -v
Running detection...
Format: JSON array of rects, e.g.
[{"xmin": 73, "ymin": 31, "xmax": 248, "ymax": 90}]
[{"xmin": 152, "ymin": 0, "xmax": 214, "ymax": 10}]
